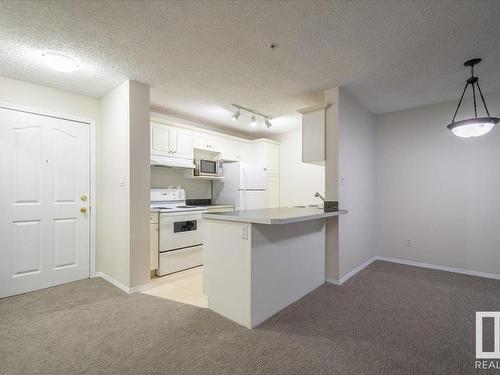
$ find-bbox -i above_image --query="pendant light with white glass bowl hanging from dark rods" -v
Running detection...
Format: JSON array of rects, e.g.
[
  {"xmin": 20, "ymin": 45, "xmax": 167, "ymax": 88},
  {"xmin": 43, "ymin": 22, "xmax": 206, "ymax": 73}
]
[{"xmin": 447, "ymin": 59, "xmax": 500, "ymax": 138}]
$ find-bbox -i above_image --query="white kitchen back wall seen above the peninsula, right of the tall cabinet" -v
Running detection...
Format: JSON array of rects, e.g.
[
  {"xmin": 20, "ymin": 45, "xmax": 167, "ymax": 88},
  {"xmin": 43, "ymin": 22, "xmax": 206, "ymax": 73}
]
[{"xmin": 273, "ymin": 130, "xmax": 325, "ymax": 207}]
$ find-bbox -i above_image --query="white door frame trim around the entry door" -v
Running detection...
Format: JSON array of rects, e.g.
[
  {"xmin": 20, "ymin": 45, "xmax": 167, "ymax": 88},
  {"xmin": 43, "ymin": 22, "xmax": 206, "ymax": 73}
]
[{"xmin": 0, "ymin": 101, "xmax": 97, "ymax": 278}]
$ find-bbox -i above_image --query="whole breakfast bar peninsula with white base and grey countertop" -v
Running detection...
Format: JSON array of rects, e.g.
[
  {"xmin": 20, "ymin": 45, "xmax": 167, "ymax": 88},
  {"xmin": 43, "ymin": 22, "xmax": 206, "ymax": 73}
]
[{"xmin": 203, "ymin": 207, "xmax": 347, "ymax": 328}]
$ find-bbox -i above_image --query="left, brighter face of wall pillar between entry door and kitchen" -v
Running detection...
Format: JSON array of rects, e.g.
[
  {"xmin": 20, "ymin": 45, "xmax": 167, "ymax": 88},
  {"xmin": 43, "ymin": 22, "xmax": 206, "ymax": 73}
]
[{"xmin": 97, "ymin": 82, "xmax": 130, "ymax": 286}]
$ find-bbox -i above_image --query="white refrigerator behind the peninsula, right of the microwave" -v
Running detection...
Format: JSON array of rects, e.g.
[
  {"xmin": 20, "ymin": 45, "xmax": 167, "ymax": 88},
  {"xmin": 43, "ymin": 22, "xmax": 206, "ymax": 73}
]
[{"xmin": 213, "ymin": 162, "xmax": 267, "ymax": 210}]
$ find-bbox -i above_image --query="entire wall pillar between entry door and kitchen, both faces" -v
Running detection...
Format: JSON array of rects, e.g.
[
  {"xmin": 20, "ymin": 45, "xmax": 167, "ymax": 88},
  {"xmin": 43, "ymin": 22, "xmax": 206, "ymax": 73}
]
[{"xmin": 98, "ymin": 81, "xmax": 150, "ymax": 288}]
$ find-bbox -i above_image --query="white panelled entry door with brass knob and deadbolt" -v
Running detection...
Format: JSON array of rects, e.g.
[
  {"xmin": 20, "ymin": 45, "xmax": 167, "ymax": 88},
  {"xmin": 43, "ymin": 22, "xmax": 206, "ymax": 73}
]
[{"xmin": 0, "ymin": 108, "xmax": 90, "ymax": 298}]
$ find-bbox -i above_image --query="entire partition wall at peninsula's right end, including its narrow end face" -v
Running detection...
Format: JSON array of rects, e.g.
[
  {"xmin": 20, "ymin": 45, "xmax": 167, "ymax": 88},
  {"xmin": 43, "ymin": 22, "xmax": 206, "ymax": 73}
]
[{"xmin": 325, "ymin": 88, "xmax": 375, "ymax": 283}]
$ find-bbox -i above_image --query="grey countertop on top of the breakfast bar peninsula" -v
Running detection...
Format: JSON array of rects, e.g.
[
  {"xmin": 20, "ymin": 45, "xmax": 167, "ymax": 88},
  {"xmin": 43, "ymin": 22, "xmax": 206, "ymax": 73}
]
[{"xmin": 203, "ymin": 207, "xmax": 347, "ymax": 225}]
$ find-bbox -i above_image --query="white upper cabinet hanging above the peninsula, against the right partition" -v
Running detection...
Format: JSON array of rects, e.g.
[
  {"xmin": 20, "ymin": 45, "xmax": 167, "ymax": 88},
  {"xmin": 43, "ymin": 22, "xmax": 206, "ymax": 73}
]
[{"xmin": 298, "ymin": 104, "xmax": 330, "ymax": 165}]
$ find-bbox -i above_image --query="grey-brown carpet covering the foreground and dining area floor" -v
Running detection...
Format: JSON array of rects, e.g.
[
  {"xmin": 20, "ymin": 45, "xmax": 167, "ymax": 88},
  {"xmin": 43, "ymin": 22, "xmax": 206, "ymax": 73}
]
[{"xmin": 0, "ymin": 261, "xmax": 500, "ymax": 375}]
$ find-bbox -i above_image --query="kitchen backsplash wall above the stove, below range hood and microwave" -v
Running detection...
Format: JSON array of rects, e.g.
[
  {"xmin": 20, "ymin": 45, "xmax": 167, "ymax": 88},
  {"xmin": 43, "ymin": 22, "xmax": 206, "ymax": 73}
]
[{"xmin": 151, "ymin": 167, "xmax": 212, "ymax": 199}]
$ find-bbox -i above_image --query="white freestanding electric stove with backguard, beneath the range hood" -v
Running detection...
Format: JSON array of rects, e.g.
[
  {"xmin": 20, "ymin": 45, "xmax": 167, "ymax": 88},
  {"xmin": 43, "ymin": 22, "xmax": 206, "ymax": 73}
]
[{"xmin": 150, "ymin": 189, "xmax": 206, "ymax": 276}]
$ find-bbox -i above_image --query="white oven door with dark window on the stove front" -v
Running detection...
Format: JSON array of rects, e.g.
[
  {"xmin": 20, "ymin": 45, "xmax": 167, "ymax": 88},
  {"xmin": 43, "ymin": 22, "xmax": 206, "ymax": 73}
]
[{"xmin": 159, "ymin": 212, "xmax": 203, "ymax": 252}]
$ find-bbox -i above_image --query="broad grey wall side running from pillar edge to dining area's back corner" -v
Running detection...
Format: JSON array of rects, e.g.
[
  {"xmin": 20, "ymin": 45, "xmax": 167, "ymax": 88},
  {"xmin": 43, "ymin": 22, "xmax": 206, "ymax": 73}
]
[{"xmin": 338, "ymin": 88, "xmax": 375, "ymax": 278}]
